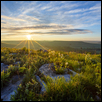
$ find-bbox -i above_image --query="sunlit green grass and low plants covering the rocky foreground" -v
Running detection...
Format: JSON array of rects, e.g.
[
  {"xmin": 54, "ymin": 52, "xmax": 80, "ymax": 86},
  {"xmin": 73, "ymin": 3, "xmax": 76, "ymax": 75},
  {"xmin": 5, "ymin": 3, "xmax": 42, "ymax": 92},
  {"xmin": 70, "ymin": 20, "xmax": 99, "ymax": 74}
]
[{"xmin": 1, "ymin": 48, "xmax": 101, "ymax": 101}]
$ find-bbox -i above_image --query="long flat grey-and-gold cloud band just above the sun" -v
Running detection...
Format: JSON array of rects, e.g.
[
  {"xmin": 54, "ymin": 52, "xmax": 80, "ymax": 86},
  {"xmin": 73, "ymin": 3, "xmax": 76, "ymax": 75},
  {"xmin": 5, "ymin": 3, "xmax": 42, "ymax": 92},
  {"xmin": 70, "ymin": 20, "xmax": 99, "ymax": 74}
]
[{"xmin": 1, "ymin": 24, "xmax": 92, "ymax": 35}]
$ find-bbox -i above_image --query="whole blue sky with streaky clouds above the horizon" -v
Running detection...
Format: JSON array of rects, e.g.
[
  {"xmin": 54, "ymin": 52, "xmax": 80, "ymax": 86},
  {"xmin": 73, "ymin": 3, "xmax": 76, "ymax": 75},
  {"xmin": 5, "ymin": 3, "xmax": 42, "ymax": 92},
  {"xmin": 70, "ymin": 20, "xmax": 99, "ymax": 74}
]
[{"xmin": 1, "ymin": 1, "xmax": 101, "ymax": 41}]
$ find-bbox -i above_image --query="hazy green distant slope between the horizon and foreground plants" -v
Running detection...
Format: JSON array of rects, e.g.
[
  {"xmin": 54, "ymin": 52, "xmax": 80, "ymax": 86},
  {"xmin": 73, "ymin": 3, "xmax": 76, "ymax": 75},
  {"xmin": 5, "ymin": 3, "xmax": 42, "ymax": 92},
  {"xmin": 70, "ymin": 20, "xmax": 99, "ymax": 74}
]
[{"xmin": 1, "ymin": 41, "xmax": 101, "ymax": 53}]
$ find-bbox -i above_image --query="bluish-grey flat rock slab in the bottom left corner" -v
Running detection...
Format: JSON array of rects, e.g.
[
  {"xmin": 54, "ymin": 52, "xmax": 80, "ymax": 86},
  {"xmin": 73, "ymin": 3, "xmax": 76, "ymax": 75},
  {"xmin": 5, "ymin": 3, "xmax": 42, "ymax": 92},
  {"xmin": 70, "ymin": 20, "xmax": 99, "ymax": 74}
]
[{"xmin": 1, "ymin": 75, "xmax": 24, "ymax": 101}]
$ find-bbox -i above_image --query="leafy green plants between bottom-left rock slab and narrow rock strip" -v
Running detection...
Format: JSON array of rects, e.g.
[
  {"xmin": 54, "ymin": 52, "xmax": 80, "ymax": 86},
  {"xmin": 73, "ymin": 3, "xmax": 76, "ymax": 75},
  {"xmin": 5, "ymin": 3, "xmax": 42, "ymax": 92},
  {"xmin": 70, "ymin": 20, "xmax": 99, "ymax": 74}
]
[{"xmin": 11, "ymin": 78, "xmax": 41, "ymax": 101}]
